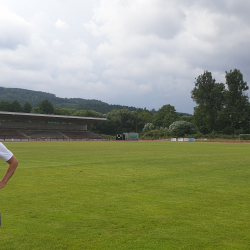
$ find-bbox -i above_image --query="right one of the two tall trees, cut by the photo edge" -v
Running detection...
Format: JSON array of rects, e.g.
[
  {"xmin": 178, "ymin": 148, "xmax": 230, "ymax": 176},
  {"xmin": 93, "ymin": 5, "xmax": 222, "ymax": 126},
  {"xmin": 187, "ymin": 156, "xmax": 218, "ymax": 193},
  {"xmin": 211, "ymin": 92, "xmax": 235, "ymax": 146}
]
[{"xmin": 225, "ymin": 69, "xmax": 249, "ymax": 132}]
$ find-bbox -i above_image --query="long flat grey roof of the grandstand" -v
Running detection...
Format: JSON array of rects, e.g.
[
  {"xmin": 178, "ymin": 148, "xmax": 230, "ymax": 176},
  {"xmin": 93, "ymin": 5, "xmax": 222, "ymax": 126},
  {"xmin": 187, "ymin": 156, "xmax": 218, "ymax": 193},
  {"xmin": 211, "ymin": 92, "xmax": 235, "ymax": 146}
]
[{"xmin": 0, "ymin": 111, "xmax": 107, "ymax": 124}]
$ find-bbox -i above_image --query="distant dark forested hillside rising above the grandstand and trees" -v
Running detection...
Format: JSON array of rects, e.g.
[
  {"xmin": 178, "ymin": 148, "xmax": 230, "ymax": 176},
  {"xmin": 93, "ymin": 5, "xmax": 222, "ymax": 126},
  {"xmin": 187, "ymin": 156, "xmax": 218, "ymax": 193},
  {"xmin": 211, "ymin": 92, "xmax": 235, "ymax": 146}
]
[{"xmin": 0, "ymin": 87, "xmax": 137, "ymax": 114}]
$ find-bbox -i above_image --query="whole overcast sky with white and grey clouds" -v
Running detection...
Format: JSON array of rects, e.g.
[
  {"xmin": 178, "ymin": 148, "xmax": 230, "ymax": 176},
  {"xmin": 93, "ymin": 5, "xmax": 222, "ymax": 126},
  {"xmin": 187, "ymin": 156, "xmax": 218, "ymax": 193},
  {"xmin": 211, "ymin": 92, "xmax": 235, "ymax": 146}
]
[{"xmin": 0, "ymin": 0, "xmax": 250, "ymax": 113}]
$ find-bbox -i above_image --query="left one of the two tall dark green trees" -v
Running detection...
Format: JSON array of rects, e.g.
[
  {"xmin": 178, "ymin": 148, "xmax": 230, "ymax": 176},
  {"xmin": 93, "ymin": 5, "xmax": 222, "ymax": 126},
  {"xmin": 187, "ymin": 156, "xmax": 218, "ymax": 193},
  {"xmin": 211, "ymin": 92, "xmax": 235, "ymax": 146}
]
[{"xmin": 191, "ymin": 71, "xmax": 225, "ymax": 133}]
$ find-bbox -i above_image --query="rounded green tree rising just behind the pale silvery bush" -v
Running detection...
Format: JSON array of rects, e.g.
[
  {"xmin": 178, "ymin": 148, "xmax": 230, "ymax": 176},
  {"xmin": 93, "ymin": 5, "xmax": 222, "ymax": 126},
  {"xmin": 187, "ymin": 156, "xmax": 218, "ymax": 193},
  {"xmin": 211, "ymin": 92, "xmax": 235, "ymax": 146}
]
[{"xmin": 153, "ymin": 104, "xmax": 178, "ymax": 128}]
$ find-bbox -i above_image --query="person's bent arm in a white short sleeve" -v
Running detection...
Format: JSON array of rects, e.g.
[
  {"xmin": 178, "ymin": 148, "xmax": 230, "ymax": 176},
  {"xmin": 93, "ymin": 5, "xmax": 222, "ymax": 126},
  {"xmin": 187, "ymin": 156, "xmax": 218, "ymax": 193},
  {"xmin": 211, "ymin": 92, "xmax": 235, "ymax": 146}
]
[{"xmin": 0, "ymin": 142, "xmax": 18, "ymax": 189}]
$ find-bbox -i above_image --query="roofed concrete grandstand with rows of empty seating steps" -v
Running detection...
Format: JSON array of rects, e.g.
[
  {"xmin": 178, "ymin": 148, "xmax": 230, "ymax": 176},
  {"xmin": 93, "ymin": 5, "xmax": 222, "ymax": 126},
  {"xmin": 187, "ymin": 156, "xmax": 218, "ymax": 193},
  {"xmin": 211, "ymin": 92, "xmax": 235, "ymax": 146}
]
[{"xmin": 0, "ymin": 111, "xmax": 106, "ymax": 141}]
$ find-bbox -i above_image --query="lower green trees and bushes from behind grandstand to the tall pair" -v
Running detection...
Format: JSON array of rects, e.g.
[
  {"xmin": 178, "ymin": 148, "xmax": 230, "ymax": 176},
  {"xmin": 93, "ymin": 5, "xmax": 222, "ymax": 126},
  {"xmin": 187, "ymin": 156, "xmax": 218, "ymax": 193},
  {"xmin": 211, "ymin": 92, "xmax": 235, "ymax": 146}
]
[{"xmin": 0, "ymin": 100, "xmax": 194, "ymax": 135}]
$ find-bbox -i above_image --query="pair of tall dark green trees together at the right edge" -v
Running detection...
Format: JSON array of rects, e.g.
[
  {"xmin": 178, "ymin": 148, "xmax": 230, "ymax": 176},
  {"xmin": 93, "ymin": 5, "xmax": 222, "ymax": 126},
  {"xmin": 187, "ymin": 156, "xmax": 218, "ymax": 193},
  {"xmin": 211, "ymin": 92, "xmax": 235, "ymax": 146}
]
[{"xmin": 191, "ymin": 69, "xmax": 250, "ymax": 134}]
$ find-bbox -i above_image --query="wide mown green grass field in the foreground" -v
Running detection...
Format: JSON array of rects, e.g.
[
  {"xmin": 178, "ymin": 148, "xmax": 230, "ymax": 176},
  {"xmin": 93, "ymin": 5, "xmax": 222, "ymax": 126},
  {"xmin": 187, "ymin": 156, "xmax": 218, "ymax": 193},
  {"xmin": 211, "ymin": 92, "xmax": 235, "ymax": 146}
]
[{"xmin": 0, "ymin": 142, "xmax": 250, "ymax": 250}]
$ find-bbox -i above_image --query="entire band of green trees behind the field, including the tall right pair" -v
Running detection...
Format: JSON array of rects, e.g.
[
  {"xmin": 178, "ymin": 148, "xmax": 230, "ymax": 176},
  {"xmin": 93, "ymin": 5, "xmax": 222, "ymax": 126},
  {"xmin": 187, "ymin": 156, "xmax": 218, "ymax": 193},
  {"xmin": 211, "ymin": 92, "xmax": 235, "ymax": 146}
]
[{"xmin": 0, "ymin": 69, "xmax": 250, "ymax": 139}]
